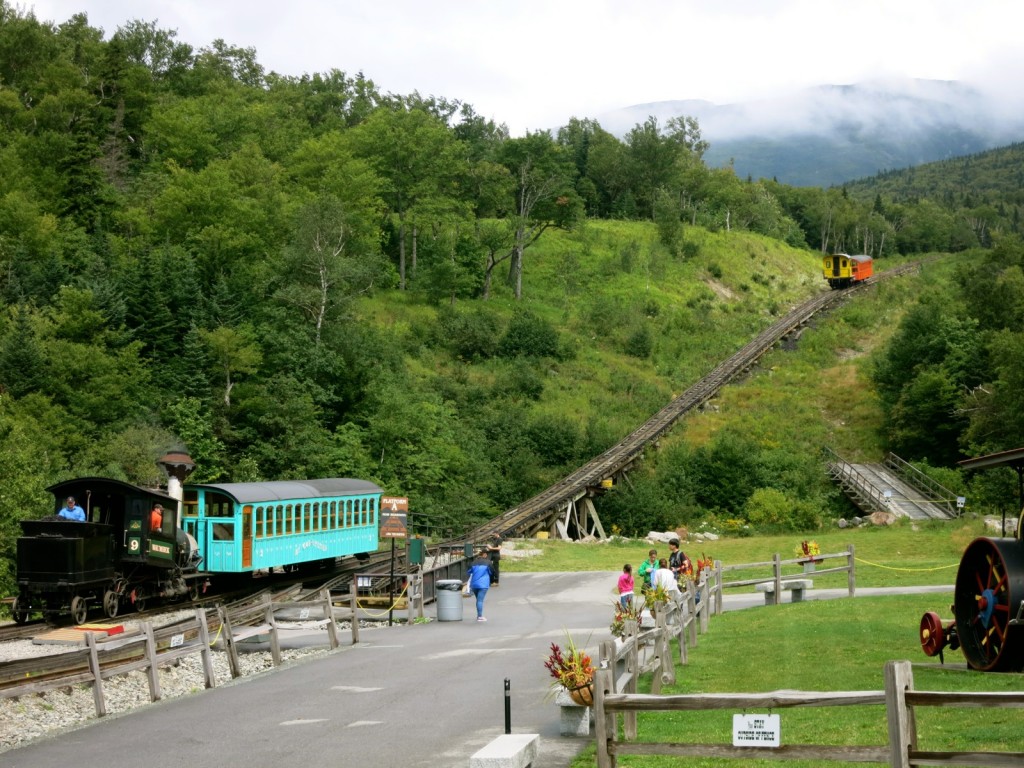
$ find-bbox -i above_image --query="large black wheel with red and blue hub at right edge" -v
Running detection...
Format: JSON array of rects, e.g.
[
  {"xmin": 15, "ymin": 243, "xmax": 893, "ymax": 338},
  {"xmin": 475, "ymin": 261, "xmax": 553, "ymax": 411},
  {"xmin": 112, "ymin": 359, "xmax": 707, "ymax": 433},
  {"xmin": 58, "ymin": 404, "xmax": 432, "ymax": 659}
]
[{"xmin": 953, "ymin": 538, "xmax": 1024, "ymax": 672}]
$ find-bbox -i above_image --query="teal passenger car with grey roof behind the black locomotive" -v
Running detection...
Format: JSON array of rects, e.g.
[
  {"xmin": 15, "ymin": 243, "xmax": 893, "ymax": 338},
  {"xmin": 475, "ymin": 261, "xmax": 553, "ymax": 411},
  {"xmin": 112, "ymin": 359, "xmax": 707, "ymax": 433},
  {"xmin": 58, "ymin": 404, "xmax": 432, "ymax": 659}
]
[{"xmin": 181, "ymin": 477, "xmax": 383, "ymax": 573}]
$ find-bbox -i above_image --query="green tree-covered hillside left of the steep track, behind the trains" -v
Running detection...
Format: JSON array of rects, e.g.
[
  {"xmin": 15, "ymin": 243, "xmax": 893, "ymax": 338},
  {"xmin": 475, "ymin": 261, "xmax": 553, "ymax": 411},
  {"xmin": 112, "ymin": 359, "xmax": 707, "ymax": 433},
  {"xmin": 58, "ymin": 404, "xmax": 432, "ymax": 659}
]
[{"xmin": 0, "ymin": 0, "xmax": 1018, "ymax": 585}]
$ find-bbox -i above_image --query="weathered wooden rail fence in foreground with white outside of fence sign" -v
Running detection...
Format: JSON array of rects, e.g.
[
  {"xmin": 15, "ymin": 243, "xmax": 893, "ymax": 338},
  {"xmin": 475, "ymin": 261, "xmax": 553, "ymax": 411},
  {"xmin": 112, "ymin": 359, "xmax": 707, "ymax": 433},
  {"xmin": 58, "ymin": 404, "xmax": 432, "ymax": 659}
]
[{"xmin": 594, "ymin": 660, "xmax": 1024, "ymax": 768}]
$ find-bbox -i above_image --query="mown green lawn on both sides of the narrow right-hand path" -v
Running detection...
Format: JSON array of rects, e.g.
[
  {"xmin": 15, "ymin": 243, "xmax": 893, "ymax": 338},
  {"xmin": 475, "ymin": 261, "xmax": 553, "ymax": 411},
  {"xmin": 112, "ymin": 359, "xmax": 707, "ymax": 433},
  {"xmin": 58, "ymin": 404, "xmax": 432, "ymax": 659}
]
[{"xmin": 502, "ymin": 520, "xmax": 1024, "ymax": 768}]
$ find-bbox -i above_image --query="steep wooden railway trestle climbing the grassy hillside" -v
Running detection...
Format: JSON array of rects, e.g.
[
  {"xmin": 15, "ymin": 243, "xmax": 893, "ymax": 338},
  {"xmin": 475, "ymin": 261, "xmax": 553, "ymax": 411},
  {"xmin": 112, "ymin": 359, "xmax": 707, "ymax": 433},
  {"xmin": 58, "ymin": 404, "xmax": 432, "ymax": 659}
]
[{"xmin": 464, "ymin": 262, "xmax": 921, "ymax": 542}]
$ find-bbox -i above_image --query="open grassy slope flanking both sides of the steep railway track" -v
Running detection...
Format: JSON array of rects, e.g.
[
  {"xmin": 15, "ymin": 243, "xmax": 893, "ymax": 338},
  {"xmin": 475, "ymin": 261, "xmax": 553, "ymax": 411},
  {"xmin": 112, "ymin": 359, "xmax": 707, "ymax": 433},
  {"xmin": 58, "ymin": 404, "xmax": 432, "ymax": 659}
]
[{"xmin": 361, "ymin": 221, "xmax": 958, "ymax": 532}]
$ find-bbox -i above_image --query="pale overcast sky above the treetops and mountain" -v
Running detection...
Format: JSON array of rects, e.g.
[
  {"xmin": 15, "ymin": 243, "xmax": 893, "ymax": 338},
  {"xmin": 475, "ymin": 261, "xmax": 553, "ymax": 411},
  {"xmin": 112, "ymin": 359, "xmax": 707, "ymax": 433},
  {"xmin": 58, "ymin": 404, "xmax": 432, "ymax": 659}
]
[{"xmin": 22, "ymin": 0, "xmax": 1024, "ymax": 135}]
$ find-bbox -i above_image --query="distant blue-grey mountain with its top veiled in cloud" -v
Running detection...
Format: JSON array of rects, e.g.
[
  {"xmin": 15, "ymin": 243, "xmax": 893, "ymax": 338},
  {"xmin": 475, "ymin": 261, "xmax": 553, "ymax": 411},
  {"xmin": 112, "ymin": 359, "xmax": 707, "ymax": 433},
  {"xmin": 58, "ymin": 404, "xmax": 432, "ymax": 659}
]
[{"xmin": 596, "ymin": 79, "xmax": 1024, "ymax": 186}]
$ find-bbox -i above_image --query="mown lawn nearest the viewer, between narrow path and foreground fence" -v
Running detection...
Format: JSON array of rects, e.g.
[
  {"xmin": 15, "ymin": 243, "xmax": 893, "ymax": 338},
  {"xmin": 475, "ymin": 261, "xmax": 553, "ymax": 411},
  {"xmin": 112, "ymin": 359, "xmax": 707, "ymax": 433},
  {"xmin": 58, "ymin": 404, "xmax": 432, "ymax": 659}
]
[{"xmin": 572, "ymin": 592, "xmax": 1024, "ymax": 768}]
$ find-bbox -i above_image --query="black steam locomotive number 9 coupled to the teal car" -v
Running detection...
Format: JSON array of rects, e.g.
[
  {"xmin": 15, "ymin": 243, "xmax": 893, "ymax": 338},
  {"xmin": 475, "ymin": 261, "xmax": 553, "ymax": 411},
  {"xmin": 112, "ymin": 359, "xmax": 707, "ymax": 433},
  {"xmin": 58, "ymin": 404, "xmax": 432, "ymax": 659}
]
[{"xmin": 11, "ymin": 477, "xmax": 204, "ymax": 624}]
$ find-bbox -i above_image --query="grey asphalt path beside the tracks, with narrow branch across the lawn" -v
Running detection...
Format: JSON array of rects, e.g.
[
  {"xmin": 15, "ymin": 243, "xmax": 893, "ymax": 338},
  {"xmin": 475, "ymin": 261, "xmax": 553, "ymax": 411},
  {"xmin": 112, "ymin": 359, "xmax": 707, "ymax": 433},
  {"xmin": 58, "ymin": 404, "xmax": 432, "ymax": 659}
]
[{"xmin": 0, "ymin": 571, "xmax": 952, "ymax": 768}]
